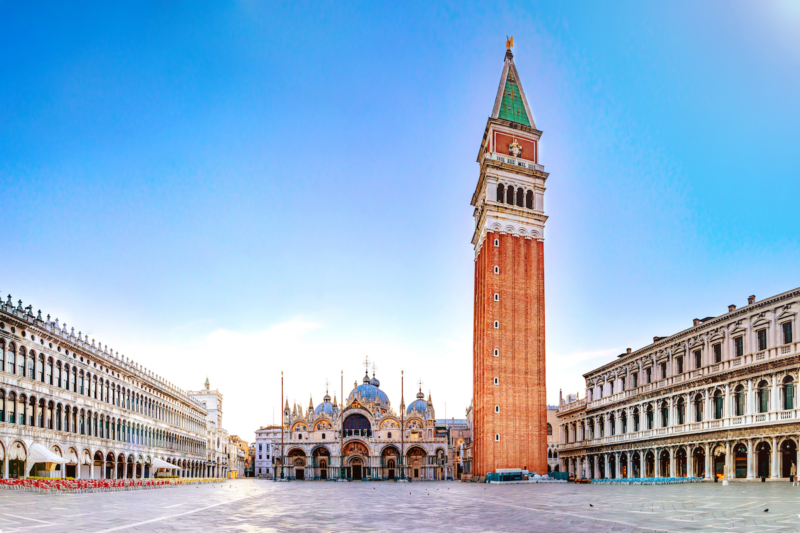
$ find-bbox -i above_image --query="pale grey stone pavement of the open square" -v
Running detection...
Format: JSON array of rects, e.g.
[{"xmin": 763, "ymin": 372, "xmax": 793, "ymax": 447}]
[{"xmin": 0, "ymin": 479, "xmax": 800, "ymax": 533}]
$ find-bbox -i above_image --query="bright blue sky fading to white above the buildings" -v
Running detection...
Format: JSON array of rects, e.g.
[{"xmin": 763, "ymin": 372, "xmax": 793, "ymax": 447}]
[{"xmin": 0, "ymin": 1, "xmax": 800, "ymax": 439}]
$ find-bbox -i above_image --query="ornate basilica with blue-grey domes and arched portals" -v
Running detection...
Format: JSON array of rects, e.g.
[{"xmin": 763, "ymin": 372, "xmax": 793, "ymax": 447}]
[{"xmin": 256, "ymin": 372, "xmax": 452, "ymax": 481}]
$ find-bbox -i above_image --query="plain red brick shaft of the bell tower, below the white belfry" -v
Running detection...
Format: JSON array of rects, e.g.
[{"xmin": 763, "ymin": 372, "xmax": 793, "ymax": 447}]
[{"xmin": 473, "ymin": 232, "xmax": 547, "ymax": 476}]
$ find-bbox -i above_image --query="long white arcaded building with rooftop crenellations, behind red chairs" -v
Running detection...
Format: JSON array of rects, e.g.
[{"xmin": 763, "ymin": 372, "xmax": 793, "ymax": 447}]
[{"xmin": 0, "ymin": 296, "xmax": 208, "ymax": 479}]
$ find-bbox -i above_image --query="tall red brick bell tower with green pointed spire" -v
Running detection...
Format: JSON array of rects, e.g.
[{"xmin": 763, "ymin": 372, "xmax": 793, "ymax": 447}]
[{"xmin": 472, "ymin": 40, "xmax": 548, "ymax": 476}]
